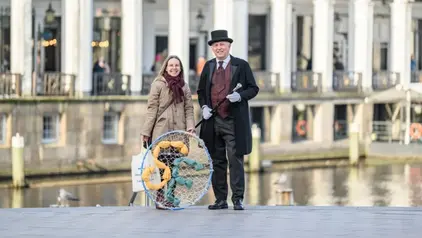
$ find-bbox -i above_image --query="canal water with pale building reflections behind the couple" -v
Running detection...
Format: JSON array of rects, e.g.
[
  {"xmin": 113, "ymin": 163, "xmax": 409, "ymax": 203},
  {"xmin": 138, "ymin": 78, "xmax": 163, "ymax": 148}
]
[{"xmin": 0, "ymin": 164, "xmax": 422, "ymax": 208}]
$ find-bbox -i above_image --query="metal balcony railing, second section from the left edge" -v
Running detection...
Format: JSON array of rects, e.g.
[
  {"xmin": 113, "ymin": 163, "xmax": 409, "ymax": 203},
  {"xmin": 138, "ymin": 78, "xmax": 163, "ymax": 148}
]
[{"xmin": 32, "ymin": 72, "xmax": 76, "ymax": 96}]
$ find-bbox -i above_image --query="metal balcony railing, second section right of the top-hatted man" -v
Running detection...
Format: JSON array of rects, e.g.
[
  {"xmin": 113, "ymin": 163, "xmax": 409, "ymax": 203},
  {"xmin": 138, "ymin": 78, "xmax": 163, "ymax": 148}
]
[{"xmin": 291, "ymin": 71, "xmax": 322, "ymax": 92}]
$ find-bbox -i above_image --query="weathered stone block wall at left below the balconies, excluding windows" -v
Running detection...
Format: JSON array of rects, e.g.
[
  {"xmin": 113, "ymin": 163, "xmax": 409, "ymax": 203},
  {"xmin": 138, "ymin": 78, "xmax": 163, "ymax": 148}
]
[{"xmin": 0, "ymin": 100, "xmax": 200, "ymax": 170}]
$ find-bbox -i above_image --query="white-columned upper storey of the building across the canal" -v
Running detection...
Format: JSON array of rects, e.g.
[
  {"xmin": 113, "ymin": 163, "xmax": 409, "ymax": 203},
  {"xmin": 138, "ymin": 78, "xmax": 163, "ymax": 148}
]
[{"xmin": 0, "ymin": 0, "xmax": 422, "ymax": 95}]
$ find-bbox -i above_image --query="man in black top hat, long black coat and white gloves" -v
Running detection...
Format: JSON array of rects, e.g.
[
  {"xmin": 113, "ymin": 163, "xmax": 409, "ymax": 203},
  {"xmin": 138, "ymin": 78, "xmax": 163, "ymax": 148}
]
[{"xmin": 197, "ymin": 30, "xmax": 259, "ymax": 210}]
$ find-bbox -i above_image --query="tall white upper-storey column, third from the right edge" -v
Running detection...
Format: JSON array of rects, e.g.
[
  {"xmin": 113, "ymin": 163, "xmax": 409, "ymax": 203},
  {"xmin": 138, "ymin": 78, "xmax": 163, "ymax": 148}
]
[{"xmin": 312, "ymin": 0, "xmax": 334, "ymax": 91}]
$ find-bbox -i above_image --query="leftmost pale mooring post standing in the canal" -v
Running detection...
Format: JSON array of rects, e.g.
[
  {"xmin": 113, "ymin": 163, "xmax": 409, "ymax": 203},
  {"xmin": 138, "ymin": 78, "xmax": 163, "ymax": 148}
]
[{"xmin": 12, "ymin": 133, "xmax": 26, "ymax": 188}]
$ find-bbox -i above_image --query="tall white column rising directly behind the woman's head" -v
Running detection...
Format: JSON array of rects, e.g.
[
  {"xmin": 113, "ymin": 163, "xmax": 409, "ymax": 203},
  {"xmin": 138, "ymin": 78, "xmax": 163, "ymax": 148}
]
[{"xmin": 168, "ymin": 0, "xmax": 190, "ymax": 83}]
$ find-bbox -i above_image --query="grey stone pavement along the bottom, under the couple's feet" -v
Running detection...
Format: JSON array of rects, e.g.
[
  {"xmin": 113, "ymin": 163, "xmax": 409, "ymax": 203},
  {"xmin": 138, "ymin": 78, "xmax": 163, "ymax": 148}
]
[{"xmin": 0, "ymin": 206, "xmax": 422, "ymax": 238}]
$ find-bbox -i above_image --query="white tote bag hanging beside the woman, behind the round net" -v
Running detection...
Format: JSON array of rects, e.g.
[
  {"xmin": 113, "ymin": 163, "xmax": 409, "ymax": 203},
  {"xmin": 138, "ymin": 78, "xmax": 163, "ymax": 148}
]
[{"xmin": 131, "ymin": 148, "xmax": 161, "ymax": 192}]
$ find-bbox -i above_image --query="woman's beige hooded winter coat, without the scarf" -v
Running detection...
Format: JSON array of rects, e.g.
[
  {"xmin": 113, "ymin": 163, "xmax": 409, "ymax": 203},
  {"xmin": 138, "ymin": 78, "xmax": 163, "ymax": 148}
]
[{"xmin": 141, "ymin": 76, "xmax": 195, "ymax": 141}]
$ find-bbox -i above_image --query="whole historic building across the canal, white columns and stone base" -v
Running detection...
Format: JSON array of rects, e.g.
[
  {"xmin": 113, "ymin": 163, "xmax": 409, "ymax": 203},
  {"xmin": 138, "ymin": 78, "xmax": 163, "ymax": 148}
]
[{"xmin": 0, "ymin": 0, "xmax": 422, "ymax": 172}]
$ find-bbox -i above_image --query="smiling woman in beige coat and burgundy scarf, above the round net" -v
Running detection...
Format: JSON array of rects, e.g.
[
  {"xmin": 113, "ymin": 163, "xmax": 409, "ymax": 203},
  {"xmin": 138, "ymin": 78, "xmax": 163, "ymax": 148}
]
[{"xmin": 141, "ymin": 55, "xmax": 195, "ymax": 208}]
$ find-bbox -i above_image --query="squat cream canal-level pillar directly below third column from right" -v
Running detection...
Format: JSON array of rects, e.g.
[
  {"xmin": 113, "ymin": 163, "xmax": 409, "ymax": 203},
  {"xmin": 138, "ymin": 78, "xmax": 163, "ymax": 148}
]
[{"xmin": 313, "ymin": 102, "xmax": 334, "ymax": 144}]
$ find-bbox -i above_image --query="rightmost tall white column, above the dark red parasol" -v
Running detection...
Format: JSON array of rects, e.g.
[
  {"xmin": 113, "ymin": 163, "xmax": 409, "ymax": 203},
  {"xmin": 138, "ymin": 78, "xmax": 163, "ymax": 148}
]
[{"xmin": 390, "ymin": 0, "xmax": 412, "ymax": 87}]
